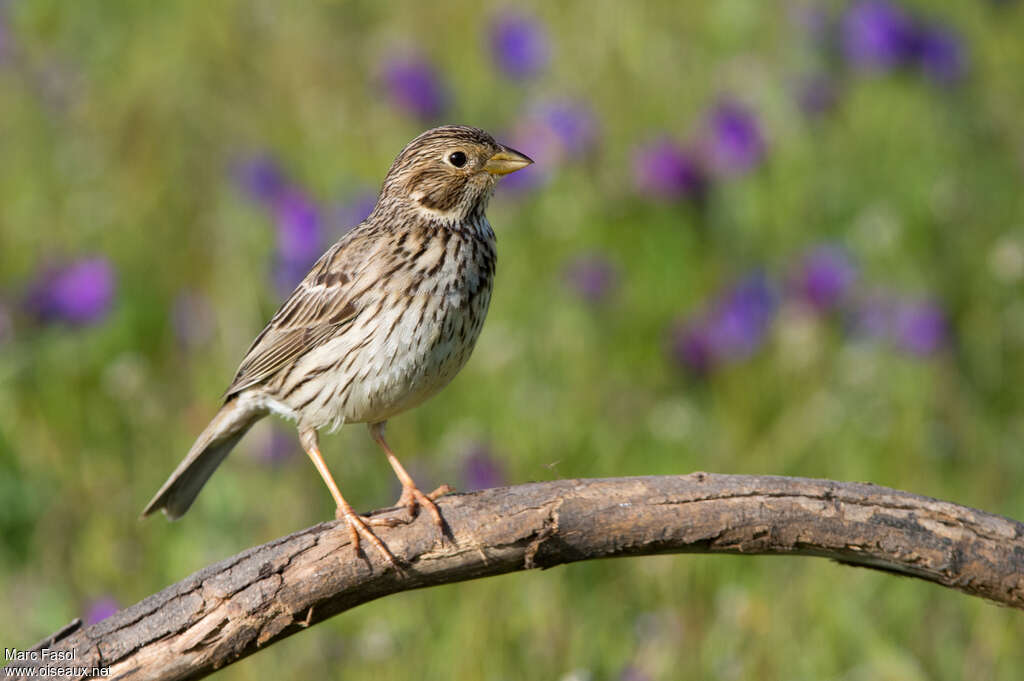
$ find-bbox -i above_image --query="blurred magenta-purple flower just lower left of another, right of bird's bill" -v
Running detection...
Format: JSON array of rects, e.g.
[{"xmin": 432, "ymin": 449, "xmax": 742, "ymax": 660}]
[{"xmin": 633, "ymin": 138, "xmax": 708, "ymax": 200}]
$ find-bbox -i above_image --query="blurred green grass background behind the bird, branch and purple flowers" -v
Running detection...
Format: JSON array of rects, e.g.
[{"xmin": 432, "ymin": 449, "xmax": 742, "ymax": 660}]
[{"xmin": 0, "ymin": 0, "xmax": 1024, "ymax": 681}]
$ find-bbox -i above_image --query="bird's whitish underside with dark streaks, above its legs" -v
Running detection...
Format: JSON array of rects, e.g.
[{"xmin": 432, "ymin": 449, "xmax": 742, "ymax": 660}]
[{"xmin": 280, "ymin": 289, "xmax": 490, "ymax": 428}]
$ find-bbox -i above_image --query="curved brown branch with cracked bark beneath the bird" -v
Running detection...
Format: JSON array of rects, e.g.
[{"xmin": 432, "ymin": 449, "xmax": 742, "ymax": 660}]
[{"xmin": 12, "ymin": 473, "xmax": 1024, "ymax": 680}]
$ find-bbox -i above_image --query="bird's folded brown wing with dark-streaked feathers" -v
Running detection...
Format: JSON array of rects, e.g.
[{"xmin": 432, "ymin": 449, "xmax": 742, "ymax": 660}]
[{"xmin": 224, "ymin": 230, "xmax": 369, "ymax": 397}]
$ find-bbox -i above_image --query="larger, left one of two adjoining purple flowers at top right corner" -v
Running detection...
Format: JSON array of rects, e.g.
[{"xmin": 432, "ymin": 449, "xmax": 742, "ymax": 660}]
[{"xmin": 840, "ymin": 0, "xmax": 915, "ymax": 71}]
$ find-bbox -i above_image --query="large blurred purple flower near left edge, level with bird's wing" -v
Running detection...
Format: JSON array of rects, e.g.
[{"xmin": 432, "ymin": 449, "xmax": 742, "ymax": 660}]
[{"xmin": 26, "ymin": 257, "xmax": 116, "ymax": 325}]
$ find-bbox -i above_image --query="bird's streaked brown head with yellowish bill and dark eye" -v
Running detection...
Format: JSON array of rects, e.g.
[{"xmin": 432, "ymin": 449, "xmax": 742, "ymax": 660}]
[{"xmin": 379, "ymin": 125, "xmax": 532, "ymax": 221}]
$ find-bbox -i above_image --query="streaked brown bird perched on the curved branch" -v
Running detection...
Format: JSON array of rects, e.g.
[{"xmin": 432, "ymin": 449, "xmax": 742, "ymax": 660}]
[{"xmin": 142, "ymin": 125, "xmax": 532, "ymax": 567}]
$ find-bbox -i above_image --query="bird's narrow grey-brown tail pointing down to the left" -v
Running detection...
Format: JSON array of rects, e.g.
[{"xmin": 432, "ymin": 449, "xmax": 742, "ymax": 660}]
[{"xmin": 142, "ymin": 399, "xmax": 266, "ymax": 520}]
